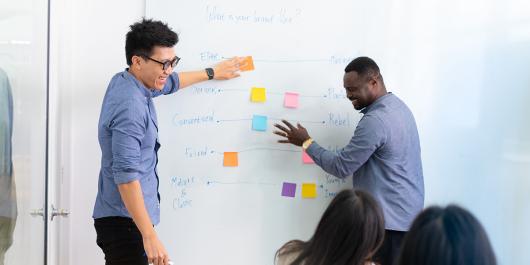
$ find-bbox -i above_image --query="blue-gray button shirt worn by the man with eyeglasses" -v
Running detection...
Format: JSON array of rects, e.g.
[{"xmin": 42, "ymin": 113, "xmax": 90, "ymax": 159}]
[{"xmin": 92, "ymin": 70, "xmax": 179, "ymax": 225}]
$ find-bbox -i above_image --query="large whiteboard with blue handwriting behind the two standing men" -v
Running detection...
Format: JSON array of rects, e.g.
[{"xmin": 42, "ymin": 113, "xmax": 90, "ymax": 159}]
[{"xmin": 146, "ymin": 0, "xmax": 530, "ymax": 264}]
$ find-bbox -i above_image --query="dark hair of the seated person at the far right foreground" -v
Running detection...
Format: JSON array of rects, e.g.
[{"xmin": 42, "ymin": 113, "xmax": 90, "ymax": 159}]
[{"xmin": 398, "ymin": 205, "xmax": 497, "ymax": 265}]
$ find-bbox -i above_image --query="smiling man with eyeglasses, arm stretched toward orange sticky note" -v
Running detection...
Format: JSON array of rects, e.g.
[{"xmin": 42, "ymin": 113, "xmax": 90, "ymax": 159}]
[{"xmin": 93, "ymin": 19, "xmax": 244, "ymax": 265}]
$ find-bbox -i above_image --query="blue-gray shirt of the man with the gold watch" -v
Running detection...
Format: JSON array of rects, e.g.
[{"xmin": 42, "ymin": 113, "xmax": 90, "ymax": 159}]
[{"xmin": 307, "ymin": 93, "xmax": 424, "ymax": 231}]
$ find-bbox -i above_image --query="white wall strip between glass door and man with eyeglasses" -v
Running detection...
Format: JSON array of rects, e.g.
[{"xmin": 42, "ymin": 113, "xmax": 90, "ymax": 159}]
[{"xmin": 51, "ymin": 0, "xmax": 145, "ymax": 265}]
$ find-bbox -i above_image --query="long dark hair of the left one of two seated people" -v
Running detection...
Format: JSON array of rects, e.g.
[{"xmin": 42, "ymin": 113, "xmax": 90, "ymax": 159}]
[{"xmin": 276, "ymin": 189, "xmax": 384, "ymax": 265}]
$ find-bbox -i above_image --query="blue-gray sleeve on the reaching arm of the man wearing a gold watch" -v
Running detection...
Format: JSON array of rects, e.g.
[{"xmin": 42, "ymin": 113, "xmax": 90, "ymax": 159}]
[{"xmin": 306, "ymin": 115, "xmax": 386, "ymax": 178}]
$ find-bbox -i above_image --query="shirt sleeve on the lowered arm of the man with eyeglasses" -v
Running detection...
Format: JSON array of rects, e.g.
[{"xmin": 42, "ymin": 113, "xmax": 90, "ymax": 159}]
[{"xmin": 109, "ymin": 101, "xmax": 146, "ymax": 184}]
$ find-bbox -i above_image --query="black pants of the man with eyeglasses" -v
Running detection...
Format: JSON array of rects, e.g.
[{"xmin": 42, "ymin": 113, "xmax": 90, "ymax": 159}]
[{"xmin": 94, "ymin": 217, "xmax": 147, "ymax": 265}]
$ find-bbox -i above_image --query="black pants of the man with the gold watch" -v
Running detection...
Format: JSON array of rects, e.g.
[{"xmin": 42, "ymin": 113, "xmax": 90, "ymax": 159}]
[{"xmin": 374, "ymin": 230, "xmax": 406, "ymax": 265}]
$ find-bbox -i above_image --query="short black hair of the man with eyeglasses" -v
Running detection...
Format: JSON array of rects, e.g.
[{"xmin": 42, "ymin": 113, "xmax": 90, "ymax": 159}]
[{"xmin": 125, "ymin": 18, "xmax": 179, "ymax": 65}]
